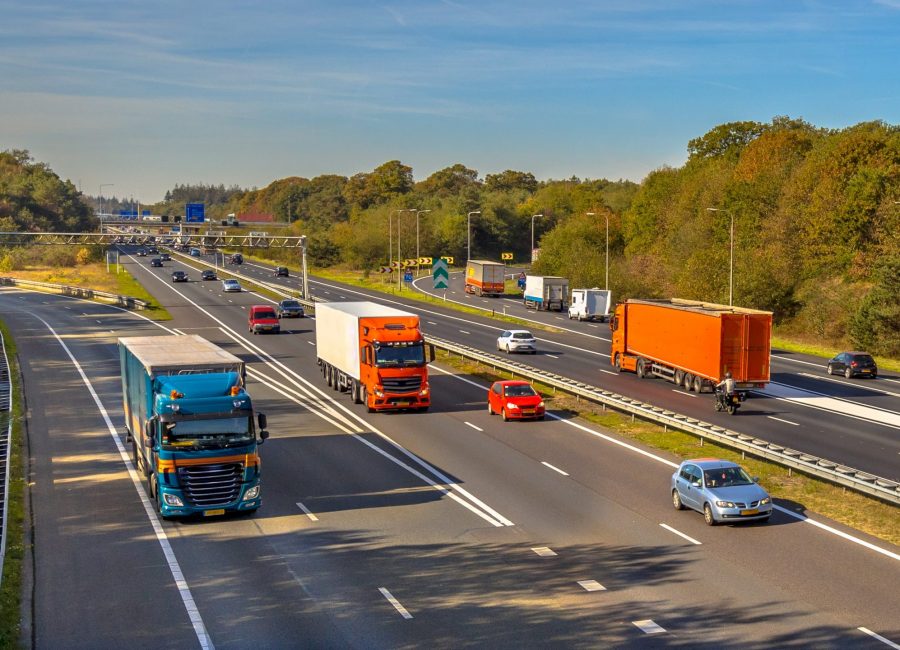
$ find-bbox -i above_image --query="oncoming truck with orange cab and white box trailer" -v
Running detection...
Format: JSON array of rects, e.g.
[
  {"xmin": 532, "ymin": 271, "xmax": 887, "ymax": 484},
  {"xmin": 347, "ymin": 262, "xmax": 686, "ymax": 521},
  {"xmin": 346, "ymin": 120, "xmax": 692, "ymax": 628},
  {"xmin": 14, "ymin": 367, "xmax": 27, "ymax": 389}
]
[{"xmin": 316, "ymin": 302, "xmax": 434, "ymax": 413}]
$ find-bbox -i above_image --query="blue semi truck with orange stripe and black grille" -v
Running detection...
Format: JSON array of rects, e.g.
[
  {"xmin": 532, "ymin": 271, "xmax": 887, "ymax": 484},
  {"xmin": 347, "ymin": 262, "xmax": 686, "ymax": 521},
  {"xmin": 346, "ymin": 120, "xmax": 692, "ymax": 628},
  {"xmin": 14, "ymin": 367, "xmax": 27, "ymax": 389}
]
[{"xmin": 119, "ymin": 335, "xmax": 269, "ymax": 517}]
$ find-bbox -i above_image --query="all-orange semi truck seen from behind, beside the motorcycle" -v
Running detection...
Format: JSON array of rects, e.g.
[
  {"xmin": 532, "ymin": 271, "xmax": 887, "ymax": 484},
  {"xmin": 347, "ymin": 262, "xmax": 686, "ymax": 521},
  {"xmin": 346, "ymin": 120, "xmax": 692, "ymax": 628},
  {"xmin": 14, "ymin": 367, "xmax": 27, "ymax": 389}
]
[{"xmin": 609, "ymin": 298, "xmax": 772, "ymax": 393}]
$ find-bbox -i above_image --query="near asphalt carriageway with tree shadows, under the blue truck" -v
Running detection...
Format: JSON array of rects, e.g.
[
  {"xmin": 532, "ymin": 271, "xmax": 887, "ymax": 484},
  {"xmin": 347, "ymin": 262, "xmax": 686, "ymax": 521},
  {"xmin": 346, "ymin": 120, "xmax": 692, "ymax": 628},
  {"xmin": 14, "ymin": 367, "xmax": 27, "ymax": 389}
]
[{"xmin": 0, "ymin": 247, "xmax": 900, "ymax": 648}]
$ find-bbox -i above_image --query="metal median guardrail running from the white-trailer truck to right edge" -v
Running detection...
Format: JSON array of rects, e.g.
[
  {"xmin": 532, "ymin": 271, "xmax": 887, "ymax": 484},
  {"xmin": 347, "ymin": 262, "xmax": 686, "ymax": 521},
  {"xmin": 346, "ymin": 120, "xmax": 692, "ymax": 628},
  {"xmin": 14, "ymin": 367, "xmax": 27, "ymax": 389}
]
[{"xmin": 426, "ymin": 336, "xmax": 900, "ymax": 505}]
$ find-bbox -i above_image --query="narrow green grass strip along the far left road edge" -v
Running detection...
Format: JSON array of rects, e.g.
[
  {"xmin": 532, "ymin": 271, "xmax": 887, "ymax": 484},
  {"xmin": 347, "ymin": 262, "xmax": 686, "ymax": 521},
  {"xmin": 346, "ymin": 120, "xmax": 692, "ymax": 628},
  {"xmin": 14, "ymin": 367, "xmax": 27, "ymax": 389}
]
[{"xmin": 0, "ymin": 321, "xmax": 25, "ymax": 648}]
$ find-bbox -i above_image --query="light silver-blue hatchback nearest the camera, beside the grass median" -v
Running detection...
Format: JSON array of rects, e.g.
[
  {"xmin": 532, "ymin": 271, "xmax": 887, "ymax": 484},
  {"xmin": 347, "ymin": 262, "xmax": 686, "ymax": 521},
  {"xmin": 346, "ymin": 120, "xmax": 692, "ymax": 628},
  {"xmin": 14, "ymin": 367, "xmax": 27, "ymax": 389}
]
[{"xmin": 671, "ymin": 458, "xmax": 772, "ymax": 526}]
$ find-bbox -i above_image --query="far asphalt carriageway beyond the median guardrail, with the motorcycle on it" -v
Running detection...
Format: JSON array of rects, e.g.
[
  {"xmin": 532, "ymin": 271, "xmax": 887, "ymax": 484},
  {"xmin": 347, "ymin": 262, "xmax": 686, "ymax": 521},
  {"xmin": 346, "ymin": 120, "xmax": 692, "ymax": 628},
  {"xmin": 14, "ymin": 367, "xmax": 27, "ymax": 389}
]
[{"xmin": 218, "ymin": 253, "xmax": 900, "ymax": 481}]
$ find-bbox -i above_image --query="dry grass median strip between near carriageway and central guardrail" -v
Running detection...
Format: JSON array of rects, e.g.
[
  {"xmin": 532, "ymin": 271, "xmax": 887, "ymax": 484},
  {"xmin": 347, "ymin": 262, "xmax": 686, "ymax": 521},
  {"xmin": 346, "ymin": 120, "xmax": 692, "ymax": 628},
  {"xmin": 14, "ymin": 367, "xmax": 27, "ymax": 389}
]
[{"xmin": 437, "ymin": 350, "xmax": 900, "ymax": 545}]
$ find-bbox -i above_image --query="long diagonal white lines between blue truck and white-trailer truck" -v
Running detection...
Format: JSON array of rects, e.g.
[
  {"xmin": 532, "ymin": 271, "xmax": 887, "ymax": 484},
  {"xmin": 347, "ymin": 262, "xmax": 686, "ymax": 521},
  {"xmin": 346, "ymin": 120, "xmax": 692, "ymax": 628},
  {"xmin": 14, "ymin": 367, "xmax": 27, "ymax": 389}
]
[{"xmin": 135, "ymin": 253, "xmax": 515, "ymax": 527}]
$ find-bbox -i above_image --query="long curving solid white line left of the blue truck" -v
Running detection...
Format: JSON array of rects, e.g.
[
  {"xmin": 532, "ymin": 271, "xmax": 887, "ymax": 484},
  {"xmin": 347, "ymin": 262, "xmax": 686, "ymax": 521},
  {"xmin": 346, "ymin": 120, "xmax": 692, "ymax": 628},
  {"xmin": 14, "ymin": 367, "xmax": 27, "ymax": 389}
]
[{"xmin": 34, "ymin": 315, "xmax": 214, "ymax": 650}]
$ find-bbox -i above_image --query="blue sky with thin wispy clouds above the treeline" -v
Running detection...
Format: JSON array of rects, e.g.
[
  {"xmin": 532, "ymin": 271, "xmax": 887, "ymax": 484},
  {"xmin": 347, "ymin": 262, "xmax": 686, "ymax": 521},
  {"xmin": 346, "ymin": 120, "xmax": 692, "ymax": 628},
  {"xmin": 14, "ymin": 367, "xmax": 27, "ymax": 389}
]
[{"xmin": 0, "ymin": 0, "xmax": 900, "ymax": 203}]
